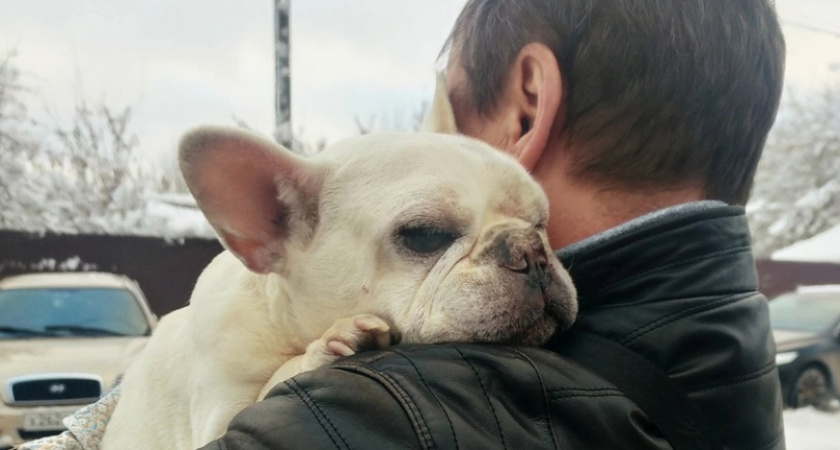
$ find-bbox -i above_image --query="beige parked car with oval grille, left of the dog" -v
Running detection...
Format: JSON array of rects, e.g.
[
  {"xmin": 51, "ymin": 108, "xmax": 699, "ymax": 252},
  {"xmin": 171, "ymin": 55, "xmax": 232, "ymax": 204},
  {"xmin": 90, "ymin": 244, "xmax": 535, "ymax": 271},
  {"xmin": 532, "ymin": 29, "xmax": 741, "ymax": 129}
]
[{"xmin": 0, "ymin": 273, "xmax": 157, "ymax": 448}]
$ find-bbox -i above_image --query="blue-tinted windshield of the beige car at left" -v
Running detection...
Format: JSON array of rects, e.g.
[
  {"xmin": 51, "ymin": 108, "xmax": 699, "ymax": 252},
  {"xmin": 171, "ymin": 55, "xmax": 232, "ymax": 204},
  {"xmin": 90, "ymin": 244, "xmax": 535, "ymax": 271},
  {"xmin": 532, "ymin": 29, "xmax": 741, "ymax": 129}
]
[{"xmin": 0, "ymin": 287, "xmax": 150, "ymax": 338}]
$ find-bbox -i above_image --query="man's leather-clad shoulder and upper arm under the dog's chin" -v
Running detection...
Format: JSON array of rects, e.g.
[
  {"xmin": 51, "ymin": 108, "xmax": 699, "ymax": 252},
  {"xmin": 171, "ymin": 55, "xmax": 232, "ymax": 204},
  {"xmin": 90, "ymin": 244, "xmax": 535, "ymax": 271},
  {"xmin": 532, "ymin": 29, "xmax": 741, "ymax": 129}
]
[{"xmin": 208, "ymin": 344, "xmax": 670, "ymax": 449}]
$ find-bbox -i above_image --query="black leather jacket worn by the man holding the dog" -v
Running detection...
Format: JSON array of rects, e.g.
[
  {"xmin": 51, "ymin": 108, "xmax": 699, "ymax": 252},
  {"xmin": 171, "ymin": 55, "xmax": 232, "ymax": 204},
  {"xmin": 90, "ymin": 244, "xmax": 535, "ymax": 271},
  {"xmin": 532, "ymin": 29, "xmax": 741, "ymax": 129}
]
[{"xmin": 204, "ymin": 203, "xmax": 784, "ymax": 450}]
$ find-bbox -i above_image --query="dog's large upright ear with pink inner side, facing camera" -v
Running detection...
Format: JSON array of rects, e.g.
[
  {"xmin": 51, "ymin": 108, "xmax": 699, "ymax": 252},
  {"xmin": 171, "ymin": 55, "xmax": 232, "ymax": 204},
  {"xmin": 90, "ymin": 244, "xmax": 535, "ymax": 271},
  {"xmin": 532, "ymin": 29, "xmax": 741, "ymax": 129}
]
[{"xmin": 179, "ymin": 127, "xmax": 326, "ymax": 273}]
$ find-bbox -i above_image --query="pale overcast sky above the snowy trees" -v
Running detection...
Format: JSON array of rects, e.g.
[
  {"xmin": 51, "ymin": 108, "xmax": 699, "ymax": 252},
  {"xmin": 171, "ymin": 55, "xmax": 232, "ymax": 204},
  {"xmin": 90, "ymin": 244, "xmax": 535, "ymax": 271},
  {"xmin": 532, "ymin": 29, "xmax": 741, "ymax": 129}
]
[{"xmin": 0, "ymin": 0, "xmax": 840, "ymax": 163}]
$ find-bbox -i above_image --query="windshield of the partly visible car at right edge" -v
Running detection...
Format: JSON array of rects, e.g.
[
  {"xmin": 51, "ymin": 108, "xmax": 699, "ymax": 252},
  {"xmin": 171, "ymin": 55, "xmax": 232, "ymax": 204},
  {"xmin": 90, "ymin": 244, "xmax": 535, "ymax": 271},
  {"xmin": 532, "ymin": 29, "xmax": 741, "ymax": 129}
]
[{"xmin": 770, "ymin": 292, "xmax": 840, "ymax": 333}]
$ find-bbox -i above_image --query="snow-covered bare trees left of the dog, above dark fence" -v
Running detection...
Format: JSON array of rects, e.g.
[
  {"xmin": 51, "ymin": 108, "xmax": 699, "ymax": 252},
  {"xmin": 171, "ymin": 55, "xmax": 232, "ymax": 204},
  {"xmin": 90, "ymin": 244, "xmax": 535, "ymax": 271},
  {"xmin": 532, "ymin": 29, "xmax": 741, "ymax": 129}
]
[{"xmin": 0, "ymin": 54, "xmax": 192, "ymax": 234}]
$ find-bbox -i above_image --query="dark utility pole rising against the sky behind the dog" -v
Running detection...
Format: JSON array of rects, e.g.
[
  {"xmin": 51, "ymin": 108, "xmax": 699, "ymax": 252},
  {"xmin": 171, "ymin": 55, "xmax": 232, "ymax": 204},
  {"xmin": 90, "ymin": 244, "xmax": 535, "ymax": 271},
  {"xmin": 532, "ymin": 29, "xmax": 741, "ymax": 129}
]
[{"xmin": 274, "ymin": 0, "xmax": 292, "ymax": 149}]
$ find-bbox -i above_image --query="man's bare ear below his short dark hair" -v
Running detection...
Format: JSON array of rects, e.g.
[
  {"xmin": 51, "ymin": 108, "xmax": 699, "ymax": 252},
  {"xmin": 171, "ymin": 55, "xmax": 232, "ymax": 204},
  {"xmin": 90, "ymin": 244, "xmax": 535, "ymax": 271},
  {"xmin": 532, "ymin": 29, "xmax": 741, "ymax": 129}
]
[{"xmin": 505, "ymin": 42, "xmax": 564, "ymax": 171}]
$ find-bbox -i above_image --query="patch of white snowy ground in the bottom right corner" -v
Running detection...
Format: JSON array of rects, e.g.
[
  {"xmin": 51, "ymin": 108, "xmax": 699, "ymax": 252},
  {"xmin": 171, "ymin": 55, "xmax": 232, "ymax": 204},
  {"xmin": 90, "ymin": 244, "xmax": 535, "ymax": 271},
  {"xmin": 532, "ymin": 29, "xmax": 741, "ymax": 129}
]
[{"xmin": 784, "ymin": 408, "xmax": 840, "ymax": 450}]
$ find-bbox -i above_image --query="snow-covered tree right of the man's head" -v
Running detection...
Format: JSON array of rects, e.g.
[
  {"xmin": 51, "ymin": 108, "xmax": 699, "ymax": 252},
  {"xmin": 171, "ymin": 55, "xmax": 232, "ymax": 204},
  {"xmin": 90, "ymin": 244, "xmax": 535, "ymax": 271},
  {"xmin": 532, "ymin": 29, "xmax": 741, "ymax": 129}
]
[{"xmin": 748, "ymin": 80, "xmax": 840, "ymax": 257}]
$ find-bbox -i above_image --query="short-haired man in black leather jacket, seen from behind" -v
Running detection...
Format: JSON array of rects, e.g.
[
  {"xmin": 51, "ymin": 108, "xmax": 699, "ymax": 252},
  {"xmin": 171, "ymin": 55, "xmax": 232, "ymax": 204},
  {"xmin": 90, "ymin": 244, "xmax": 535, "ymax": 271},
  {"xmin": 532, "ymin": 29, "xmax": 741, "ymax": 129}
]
[{"xmin": 205, "ymin": 0, "xmax": 784, "ymax": 450}]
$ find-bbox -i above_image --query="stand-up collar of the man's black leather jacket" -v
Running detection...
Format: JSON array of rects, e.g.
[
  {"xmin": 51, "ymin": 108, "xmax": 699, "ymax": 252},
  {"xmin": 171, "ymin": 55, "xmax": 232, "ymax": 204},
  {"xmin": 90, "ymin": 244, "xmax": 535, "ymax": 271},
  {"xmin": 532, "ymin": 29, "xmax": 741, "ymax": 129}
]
[{"xmin": 557, "ymin": 201, "xmax": 758, "ymax": 312}]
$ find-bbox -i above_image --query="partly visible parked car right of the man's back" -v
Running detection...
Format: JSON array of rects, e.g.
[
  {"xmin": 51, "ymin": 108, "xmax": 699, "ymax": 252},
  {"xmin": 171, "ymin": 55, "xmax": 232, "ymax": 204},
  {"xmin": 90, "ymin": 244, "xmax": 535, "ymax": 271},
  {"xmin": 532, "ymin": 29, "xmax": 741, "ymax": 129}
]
[{"xmin": 770, "ymin": 285, "xmax": 840, "ymax": 409}]
